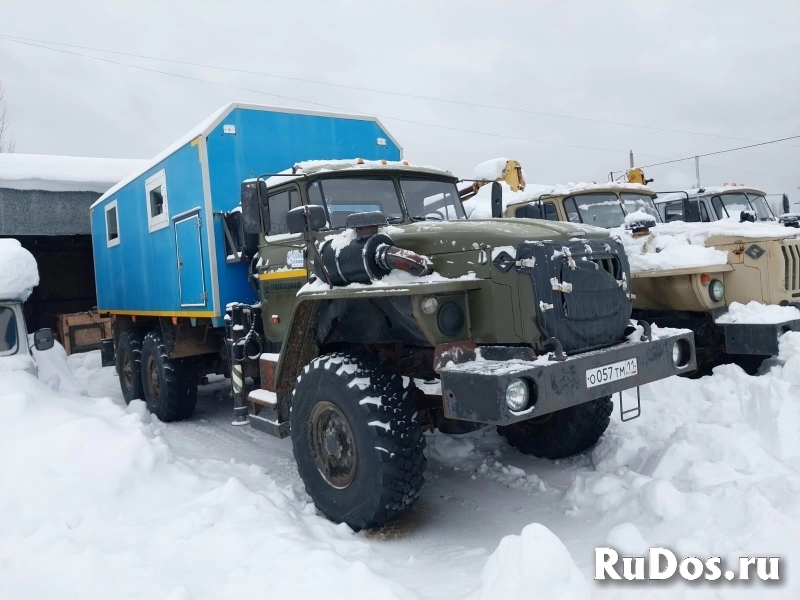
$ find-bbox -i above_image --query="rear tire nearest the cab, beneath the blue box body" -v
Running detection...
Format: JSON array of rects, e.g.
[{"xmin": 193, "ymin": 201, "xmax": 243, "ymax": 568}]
[{"xmin": 141, "ymin": 330, "xmax": 198, "ymax": 423}]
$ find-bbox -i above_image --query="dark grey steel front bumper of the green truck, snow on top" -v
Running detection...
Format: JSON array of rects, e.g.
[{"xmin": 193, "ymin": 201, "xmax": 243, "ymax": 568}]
[{"xmin": 437, "ymin": 331, "xmax": 697, "ymax": 425}]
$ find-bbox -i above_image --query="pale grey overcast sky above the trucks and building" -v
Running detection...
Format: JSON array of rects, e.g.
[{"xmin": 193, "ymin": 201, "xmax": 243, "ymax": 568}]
[{"xmin": 0, "ymin": 0, "xmax": 800, "ymax": 203}]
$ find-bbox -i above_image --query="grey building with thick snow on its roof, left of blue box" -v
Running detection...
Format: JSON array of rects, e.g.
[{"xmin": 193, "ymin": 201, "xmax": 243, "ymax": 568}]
[{"xmin": 0, "ymin": 154, "xmax": 145, "ymax": 330}]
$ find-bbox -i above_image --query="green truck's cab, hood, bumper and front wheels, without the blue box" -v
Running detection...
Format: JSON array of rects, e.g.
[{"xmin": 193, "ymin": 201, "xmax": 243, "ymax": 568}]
[{"xmin": 226, "ymin": 161, "xmax": 695, "ymax": 529}]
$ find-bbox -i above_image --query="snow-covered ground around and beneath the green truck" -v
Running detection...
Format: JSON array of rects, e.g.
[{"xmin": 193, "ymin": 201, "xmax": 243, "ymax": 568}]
[{"xmin": 0, "ymin": 340, "xmax": 800, "ymax": 600}]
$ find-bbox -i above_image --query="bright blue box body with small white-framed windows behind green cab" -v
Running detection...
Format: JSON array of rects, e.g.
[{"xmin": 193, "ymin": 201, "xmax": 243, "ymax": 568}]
[{"xmin": 90, "ymin": 104, "xmax": 402, "ymax": 327}]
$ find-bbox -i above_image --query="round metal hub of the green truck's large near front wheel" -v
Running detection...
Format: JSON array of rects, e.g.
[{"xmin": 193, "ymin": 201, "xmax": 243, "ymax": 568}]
[{"xmin": 308, "ymin": 400, "xmax": 358, "ymax": 489}]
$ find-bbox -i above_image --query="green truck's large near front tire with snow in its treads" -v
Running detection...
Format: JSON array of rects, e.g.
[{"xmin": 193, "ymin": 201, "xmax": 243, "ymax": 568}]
[{"xmin": 291, "ymin": 353, "xmax": 425, "ymax": 531}]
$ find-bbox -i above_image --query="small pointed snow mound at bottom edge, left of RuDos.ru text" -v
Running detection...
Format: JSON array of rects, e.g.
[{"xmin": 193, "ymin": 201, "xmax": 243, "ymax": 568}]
[{"xmin": 480, "ymin": 523, "xmax": 590, "ymax": 600}]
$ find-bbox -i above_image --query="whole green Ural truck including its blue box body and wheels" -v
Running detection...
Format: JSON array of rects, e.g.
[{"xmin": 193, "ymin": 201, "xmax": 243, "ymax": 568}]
[{"xmin": 93, "ymin": 108, "xmax": 695, "ymax": 529}]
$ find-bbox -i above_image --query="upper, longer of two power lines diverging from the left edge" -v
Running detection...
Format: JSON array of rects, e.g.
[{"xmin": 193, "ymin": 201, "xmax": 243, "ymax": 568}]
[{"xmin": 0, "ymin": 34, "xmax": 800, "ymax": 147}]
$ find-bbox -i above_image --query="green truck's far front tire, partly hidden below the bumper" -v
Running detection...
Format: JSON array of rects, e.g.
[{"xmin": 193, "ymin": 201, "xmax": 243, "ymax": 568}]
[{"xmin": 497, "ymin": 396, "xmax": 614, "ymax": 459}]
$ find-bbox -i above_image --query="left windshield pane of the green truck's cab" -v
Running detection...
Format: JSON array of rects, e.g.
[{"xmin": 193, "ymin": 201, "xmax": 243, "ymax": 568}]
[{"xmin": 308, "ymin": 177, "xmax": 403, "ymax": 229}]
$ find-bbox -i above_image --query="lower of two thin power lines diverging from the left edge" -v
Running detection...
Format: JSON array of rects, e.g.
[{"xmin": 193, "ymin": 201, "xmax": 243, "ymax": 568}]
[{"xmin": 0, "ymin": 36, "xmax": 663, "ymax": 158}]
